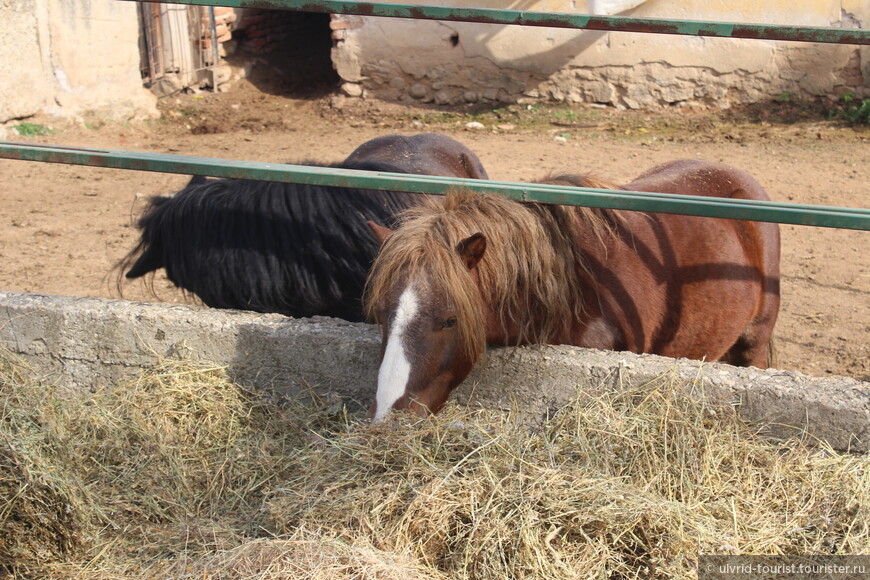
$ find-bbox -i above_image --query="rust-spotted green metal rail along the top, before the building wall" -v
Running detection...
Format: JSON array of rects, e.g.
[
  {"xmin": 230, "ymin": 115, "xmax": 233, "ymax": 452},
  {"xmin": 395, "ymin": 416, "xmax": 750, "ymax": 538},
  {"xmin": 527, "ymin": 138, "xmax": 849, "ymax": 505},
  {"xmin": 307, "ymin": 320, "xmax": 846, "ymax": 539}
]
[{"xmin": 128, "ymin": 0, "xmax": 870, "ymax": 45}]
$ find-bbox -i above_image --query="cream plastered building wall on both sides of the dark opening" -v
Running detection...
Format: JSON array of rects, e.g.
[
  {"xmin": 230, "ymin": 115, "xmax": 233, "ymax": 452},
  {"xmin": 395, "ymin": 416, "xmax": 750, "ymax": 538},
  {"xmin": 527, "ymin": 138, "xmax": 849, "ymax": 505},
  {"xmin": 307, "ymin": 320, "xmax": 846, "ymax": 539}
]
[{"xmin": 0, "ymin": 0, "xmax": 870, "ymax": 124}]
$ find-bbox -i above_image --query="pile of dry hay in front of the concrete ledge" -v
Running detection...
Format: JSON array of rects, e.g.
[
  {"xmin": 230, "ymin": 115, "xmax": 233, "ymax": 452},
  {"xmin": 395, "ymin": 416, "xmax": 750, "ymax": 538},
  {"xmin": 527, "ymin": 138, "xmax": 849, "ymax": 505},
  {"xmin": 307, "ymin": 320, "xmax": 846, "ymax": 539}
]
[{"xmin": 0, "ymin": 355, "xmax": 870, "ymax": 580}]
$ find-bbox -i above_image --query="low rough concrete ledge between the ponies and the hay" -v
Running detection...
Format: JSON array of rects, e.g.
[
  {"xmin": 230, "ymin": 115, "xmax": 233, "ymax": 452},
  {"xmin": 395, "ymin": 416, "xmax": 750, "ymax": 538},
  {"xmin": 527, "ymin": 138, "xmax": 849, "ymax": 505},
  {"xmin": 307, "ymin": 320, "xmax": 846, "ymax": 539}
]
[{"xmin": 0, "ymin": 292, "xmax": 870, "ymax": 452}]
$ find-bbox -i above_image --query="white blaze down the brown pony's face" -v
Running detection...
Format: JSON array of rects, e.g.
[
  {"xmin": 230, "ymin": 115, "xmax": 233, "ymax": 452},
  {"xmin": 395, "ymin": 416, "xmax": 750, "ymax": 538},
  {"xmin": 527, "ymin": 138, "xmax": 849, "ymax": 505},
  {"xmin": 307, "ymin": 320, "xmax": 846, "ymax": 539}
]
[{"xmin": 374, "ymin": 286, "xmax": 420, "ymax": 422}]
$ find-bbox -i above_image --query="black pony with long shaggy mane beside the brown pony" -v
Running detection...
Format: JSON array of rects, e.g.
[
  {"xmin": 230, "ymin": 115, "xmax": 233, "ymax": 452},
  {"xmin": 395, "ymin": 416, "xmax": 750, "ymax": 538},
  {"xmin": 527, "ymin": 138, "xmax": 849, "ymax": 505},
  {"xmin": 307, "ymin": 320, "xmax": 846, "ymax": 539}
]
[{"xmin": 120, "ymin": 133, "xmax": 487, "ymax": 321}]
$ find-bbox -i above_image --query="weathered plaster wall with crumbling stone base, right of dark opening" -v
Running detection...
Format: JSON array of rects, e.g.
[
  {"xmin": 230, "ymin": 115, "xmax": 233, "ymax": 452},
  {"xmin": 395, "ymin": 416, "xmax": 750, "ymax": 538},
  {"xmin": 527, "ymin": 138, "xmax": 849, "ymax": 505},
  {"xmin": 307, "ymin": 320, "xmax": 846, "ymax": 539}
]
[{"xmin": 333, "ymin": 0, "xmax": 870, "ymax": 108}]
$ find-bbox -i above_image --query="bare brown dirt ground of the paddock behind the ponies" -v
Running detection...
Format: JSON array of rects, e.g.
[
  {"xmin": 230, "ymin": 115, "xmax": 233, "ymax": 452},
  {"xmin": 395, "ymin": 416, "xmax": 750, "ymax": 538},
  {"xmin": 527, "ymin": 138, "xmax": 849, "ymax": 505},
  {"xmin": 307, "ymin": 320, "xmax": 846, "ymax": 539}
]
[{"xmin": 0, "ymin": 73, "xmax": 870, "ymax": 380}]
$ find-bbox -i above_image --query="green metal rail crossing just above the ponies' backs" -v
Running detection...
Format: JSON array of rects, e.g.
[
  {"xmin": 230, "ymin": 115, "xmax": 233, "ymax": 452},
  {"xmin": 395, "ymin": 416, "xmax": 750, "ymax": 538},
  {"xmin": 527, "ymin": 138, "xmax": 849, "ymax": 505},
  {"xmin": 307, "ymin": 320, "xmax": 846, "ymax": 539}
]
[{"xmin": 0, "ymin": 141, "xmax": 870, "ymax": 231}]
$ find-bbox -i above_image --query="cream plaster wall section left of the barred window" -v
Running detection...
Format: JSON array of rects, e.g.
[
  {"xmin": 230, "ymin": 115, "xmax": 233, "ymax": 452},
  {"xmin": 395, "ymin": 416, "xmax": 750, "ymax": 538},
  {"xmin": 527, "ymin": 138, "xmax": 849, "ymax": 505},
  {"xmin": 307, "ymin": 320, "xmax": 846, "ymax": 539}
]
[{"xmin": 0, "ymin": 0, "xmax": 157, "ymax": 123}]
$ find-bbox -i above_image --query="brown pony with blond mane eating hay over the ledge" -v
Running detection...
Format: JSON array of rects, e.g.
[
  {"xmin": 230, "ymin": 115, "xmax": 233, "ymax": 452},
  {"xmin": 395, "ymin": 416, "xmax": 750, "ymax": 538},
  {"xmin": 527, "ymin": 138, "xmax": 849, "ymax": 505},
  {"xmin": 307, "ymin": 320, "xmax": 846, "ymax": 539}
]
[{"xmin": 364, "ymin": 160, "xmax": 779, "ymax": 420}]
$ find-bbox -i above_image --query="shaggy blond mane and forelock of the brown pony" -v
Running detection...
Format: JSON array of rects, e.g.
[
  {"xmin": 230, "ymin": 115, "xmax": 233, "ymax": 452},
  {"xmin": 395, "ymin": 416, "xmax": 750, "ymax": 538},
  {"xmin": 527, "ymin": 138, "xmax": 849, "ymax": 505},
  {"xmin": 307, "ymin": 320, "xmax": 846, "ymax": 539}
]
[{"xmin": 364, "ymin": 175, "xmax": 617, "ymax": 358}]
